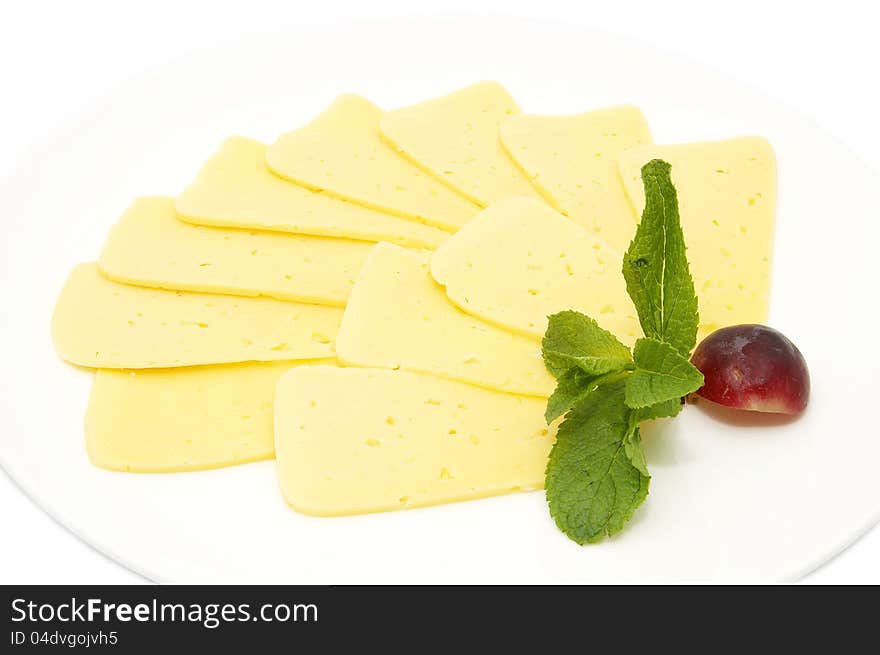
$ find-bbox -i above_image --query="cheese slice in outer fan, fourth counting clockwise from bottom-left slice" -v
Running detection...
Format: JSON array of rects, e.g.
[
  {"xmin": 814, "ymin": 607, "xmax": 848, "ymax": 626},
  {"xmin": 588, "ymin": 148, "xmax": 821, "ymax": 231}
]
[{"xmin": 175, "ymin": 136, "xmax": 449, "ymax": 248}]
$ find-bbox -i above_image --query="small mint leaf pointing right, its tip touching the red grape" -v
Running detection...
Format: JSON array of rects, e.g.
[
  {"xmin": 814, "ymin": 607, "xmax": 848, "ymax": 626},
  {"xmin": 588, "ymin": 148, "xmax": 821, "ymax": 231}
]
[{"xmin": 626, "ymin": 339, "xmax": 703, "ymax": 409}]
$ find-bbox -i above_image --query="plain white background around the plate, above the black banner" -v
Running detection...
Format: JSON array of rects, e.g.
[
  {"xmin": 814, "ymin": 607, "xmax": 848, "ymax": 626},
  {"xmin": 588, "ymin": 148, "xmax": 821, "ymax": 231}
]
[{"xmin": 0, "ymin": 0, "xmax": 880, "ymax": 584}]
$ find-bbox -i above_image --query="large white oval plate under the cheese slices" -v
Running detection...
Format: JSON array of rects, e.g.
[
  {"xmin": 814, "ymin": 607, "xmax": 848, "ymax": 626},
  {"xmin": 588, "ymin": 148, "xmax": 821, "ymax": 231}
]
[{"xmin": 0, "ymin": 19, "xmax": 880, "ymax": 583}]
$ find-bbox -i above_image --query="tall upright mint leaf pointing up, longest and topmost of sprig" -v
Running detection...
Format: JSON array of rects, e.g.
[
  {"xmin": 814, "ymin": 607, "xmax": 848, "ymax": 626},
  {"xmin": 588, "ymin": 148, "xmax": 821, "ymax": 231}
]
[{"xmin": 623, "ymin": 159, "xmax": 698, "ymax": 357}]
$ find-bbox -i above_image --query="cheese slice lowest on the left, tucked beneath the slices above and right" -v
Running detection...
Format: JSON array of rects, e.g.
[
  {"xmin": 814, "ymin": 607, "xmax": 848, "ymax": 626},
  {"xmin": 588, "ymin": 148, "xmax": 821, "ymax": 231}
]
[{"xmin": 86, "ymin": 360, "xmax": 331, "ymax": 473}]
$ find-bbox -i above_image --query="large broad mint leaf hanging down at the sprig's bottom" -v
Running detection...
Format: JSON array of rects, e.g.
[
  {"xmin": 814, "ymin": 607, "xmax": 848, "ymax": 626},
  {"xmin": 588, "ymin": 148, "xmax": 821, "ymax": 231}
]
[{"xmin": 546, "ymin": 376, "xmax": 650, "ymax": 544}]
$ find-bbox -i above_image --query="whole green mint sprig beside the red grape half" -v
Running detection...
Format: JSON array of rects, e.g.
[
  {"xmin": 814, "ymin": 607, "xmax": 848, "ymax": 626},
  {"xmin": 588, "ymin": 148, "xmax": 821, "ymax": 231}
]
[{"xmin": 542, "ymin": 159, "xmax": 703, "ymax": 544}]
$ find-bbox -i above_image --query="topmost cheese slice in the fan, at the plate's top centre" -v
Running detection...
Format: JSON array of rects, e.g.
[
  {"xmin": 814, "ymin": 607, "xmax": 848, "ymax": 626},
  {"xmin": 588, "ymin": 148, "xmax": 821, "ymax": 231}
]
[{"xmin": 379, "ymin": 82, "xmax": 540, "ymax": 206}]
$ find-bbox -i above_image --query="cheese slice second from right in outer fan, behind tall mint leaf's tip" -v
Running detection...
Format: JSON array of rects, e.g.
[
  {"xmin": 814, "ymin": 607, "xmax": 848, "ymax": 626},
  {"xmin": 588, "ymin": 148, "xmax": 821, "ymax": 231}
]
[{"xmin": 501, "ymin": 107, "xmax": 651, "ymax": 253}]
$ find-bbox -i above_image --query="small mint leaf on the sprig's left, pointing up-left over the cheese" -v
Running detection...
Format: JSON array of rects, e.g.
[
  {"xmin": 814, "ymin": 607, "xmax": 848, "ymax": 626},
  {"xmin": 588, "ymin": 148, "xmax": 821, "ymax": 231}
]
[{"xmin": 541, "ymin": 310, "xmax": 632, "ymax": 379}]
